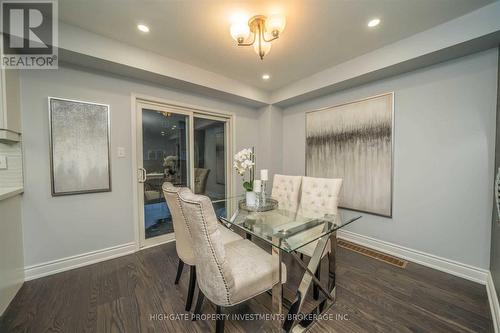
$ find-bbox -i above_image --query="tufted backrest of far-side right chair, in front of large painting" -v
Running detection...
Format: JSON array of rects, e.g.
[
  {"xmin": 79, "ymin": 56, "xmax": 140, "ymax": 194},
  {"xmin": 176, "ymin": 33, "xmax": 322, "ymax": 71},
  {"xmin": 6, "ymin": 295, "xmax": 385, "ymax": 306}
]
[{"xmin": 299, "ymin": 177, "xmax": 342, "ymax": 217}]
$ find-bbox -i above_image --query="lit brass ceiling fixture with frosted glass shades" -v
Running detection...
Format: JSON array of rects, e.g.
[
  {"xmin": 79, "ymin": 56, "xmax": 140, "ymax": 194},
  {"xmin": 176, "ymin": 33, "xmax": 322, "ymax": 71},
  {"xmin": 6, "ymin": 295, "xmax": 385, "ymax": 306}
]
[{"xmin": 230, "ymin": 15, "xmax": 286, "ymax": 59}]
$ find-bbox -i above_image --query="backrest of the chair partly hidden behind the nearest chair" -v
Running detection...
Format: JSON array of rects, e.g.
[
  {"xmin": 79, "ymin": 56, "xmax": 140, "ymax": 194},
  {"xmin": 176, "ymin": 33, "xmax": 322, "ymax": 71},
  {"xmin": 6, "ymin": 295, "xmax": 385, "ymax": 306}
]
[{"xmin": 162, "ymin": 182, "xmax": 195, "ymax": 266}]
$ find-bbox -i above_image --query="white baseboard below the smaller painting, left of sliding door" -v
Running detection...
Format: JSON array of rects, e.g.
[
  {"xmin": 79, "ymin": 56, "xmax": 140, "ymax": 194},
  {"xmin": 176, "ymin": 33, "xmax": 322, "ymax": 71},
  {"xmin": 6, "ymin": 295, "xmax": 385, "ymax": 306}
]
[{"xmin": 24, "ymin": 242, "xmax": 136, "ymax": 281}]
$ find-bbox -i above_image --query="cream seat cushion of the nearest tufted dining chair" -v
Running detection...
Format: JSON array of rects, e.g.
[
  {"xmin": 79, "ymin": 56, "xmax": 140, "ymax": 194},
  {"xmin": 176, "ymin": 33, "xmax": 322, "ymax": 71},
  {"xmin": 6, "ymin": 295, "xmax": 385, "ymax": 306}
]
[{"xmin": 225, "ymin": 239, "xmax": 286, "ymax": 305}]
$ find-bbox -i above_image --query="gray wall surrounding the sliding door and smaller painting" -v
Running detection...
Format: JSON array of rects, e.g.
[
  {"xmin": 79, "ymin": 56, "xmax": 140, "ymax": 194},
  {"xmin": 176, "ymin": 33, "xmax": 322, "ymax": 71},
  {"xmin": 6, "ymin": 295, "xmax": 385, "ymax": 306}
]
[{"xmin": 21, "ymin": 67, "xmax": 258, "ymax": 266}]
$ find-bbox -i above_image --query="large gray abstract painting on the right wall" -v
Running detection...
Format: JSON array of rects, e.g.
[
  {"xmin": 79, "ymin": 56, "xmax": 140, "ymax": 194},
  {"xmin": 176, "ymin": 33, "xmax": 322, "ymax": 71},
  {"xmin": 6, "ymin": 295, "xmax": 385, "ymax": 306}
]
[{"xmin": 306, "ymin": 93, "xmax": 394, "ymax": 217}]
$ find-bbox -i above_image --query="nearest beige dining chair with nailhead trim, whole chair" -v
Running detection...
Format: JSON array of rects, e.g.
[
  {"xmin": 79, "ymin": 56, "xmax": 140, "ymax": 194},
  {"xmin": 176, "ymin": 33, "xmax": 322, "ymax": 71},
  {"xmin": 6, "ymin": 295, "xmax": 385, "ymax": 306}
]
[{"xmin": 179, "ymin": 189, "xmax": 286, "ymax": 333}]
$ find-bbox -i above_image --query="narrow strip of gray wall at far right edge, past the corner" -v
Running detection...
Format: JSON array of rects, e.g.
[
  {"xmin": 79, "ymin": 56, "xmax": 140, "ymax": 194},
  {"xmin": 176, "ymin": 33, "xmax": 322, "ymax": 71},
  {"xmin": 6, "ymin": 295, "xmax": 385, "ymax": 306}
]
[{"xmin": 490, "ymin": 47, "xmax": 500, "ymax": 298}]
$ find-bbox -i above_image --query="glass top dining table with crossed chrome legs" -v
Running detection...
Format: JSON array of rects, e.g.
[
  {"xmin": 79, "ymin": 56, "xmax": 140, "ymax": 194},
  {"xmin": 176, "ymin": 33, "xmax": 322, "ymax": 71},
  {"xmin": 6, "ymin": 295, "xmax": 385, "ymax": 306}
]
[{"xmin": 212, "ymin": 196, "xmax": 361, "ymax": 333}]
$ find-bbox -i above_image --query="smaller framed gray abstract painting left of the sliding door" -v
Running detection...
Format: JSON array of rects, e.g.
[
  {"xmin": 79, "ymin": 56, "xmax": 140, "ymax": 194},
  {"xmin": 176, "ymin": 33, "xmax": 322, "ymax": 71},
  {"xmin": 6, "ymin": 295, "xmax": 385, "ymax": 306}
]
[{"xmin": 49, "ymin": 97, "xmax": 111, "ymax": 196}]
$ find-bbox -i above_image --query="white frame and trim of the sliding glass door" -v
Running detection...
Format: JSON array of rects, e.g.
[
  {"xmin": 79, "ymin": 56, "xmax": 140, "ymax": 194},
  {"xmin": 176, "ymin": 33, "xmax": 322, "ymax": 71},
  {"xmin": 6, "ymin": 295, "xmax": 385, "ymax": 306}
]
[{"xmin": 130, "ymin": 93, "xmax": 235, "ymax": 251}]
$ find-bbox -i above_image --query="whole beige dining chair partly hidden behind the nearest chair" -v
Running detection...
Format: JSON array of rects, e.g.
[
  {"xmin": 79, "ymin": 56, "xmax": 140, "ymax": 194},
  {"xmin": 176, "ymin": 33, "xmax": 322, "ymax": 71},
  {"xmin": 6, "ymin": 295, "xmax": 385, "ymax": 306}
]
[{"xmin": 162, "ymin": 182, "xmax": 243, "ymax": 311}]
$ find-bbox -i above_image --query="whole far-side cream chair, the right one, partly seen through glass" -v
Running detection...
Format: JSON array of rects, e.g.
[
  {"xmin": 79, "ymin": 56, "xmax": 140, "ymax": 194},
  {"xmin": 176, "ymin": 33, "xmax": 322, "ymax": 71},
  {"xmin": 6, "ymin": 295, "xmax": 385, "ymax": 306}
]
[{"xmin": 297, "ymin": 177, "xmax": 342, "ymax": 299}]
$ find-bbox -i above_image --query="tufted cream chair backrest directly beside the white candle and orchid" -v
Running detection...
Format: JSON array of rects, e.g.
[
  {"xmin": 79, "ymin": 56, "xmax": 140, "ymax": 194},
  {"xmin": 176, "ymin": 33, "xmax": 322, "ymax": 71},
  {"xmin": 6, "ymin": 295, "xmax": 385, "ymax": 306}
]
[{"xmin": 271, "ymin": 174, "xmax": 302, "ymax": 212}]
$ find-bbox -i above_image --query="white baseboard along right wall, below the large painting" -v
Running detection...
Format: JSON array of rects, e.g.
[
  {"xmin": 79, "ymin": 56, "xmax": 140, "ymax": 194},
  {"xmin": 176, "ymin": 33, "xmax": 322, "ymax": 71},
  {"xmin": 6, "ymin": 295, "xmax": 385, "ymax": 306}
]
[{"xmin": 337, "ymin": 230, "xmax": 489, "ymax": 285}]
